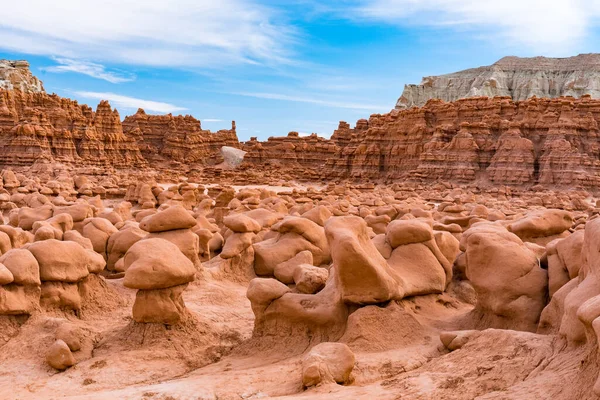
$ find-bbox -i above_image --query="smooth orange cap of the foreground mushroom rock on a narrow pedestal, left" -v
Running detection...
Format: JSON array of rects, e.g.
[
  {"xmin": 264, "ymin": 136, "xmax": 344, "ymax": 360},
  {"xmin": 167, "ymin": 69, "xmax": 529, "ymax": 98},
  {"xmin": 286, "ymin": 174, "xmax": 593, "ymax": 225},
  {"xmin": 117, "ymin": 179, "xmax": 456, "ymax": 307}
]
[{"xmin": 123, "ymin": 238, "xmax": 196, "ymax": 290}]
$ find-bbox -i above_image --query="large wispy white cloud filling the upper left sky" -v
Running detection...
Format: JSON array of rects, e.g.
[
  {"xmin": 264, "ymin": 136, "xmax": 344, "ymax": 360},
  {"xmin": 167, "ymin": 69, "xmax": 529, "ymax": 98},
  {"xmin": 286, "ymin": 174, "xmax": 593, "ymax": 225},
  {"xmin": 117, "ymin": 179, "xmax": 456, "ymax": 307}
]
[{"xmin": 0, "ymin": 0, "xmax": 294, "ymax": 67}]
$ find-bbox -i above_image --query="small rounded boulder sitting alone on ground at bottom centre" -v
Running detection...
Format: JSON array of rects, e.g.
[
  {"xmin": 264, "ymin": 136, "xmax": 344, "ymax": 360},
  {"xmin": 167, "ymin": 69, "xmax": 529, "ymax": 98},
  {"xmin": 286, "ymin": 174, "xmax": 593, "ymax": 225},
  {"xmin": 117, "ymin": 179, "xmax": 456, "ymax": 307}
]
[{"xmin": 302, "ymin": 342, "xmax": 356, "ymax": 387}]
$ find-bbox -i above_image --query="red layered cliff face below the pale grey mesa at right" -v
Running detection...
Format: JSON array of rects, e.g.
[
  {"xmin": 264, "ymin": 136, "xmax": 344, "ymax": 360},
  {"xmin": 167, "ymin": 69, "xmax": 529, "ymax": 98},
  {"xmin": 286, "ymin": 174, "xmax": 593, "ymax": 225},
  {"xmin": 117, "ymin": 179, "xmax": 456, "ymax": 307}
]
[{"xmin": 324, "ymin": 96, "xmax": 600, "ymax": 187}]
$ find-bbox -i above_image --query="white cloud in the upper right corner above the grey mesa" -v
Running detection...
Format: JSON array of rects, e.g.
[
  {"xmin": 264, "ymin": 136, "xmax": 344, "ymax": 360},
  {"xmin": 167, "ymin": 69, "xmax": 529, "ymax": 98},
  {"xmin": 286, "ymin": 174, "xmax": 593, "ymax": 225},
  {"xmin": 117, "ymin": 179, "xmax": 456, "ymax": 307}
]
[{"xmin": 353, "ymin": 0, "xmax": 600, "ymax": 55}]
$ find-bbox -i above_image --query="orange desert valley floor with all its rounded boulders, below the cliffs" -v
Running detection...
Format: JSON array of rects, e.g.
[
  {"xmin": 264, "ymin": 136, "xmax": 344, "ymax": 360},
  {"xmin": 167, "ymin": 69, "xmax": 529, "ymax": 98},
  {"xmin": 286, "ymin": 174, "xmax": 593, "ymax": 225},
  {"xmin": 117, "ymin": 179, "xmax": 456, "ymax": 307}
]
[{"xmin": 0, "ymin": 170, "xmax": 600, "ymax": 399}]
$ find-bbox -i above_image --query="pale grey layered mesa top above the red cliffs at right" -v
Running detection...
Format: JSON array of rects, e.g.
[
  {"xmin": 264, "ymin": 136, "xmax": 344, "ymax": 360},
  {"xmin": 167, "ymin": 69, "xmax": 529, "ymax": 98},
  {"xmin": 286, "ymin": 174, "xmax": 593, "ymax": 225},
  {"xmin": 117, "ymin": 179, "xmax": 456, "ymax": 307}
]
[{"xmin": 396, "ymin": 54, "xmax": 600, "ymax": 109}]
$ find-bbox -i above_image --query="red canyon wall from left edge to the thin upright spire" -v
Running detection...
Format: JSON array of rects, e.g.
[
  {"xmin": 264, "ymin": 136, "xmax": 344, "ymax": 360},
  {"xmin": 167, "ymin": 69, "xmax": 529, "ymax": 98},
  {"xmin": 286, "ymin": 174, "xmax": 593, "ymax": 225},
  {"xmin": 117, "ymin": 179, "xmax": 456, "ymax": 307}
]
[{"xmin": 0, "ymin": 89, "xmax": 240, "ymax": 168}]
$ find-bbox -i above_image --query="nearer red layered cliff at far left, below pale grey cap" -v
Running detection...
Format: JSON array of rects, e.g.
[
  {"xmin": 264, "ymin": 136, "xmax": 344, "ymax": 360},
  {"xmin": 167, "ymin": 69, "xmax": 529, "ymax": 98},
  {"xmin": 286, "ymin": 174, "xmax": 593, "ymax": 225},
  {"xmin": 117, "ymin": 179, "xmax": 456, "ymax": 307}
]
[{"xmin": 0, "ymin": 90, "xmax": 146, "ymax": 167}]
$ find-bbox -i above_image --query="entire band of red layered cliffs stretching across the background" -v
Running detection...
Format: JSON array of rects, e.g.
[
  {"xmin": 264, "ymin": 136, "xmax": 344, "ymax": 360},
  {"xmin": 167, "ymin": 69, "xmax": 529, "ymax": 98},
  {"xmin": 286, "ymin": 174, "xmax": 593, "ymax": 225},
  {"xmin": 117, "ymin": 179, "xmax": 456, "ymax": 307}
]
[{"xmin": 0, "ymin": 58, "xmax": 600, "ymax": 190}]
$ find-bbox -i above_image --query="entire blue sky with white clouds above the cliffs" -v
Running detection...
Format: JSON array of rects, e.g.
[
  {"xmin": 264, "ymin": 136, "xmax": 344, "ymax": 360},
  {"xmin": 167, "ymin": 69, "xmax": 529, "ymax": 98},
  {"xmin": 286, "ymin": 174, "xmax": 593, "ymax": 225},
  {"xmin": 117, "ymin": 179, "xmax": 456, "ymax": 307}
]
[{"xmin": 0, "ymin": 0, "xmax": 600, "ymax": 140}]
